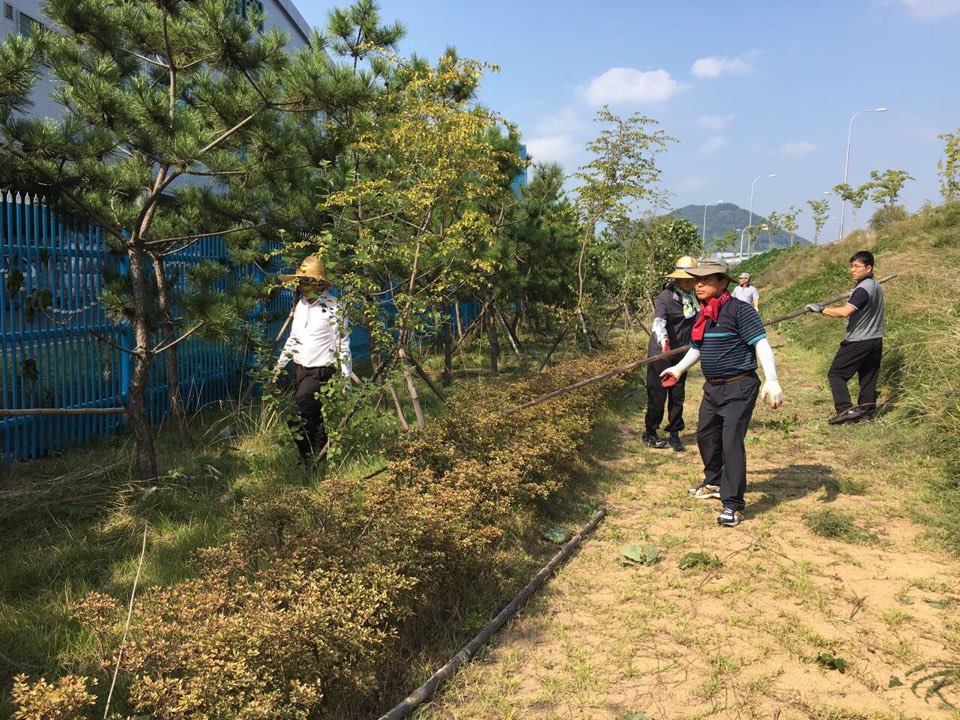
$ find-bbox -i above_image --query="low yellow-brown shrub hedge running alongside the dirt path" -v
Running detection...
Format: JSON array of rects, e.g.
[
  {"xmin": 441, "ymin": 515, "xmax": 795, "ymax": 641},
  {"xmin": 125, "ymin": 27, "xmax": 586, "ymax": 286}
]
[{"xmin": 14, "ymin": 349, "xmax": 635, "ymax": 720}]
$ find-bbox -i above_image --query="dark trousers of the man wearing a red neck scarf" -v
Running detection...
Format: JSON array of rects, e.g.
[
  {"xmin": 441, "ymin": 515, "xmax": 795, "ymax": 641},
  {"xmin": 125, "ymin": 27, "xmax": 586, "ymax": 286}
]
[{"xmin": 697, "ymin": 373, "xmax": 760, "ymax": 510}]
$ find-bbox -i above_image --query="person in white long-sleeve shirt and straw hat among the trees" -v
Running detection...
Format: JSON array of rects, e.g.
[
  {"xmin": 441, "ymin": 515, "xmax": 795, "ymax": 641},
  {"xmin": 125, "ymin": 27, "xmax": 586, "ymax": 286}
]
[{"xmin": 276, "ymin": 255, "xmax": 352, "ymax": 462}]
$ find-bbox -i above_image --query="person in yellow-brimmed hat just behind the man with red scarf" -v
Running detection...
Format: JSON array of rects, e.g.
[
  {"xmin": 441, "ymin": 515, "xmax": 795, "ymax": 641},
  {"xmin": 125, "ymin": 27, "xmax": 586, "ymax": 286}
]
[{"xmin": 642, "ymin": 255, "xmax": 700, "ymax": 452}]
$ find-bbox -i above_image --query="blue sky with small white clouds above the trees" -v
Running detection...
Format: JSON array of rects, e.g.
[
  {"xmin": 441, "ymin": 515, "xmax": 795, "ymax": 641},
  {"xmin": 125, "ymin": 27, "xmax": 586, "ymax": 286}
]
[{"xmin": 297, "ymin": 0, "xmax": 960, "ymax": 239}]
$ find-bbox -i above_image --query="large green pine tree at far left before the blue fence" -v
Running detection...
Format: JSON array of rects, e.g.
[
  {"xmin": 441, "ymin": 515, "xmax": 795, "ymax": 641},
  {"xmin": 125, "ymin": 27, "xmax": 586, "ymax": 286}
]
[{"xmin": 0, "ymin": 0, "xmax": 357, "ymax": 481}]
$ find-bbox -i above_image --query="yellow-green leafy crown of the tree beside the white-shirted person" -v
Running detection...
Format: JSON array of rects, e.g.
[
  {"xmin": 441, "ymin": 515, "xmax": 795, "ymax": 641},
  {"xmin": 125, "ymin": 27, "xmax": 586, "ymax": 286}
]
[{"xmin": 313, "ymin": 52, "xmax": 519, "ymax": 372}]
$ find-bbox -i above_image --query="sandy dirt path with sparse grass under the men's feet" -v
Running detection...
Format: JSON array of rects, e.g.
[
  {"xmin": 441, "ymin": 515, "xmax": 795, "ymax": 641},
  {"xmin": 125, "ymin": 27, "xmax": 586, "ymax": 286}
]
[{"xmin": 416, "ymin": 338, "xmax": 960, "ymax": 720}]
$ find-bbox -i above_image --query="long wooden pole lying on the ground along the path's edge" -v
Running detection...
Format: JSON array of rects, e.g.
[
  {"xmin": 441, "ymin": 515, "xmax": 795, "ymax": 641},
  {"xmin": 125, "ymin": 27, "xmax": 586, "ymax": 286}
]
[{"xmin": 380, "ymin": 510, "xmax": 607, "ymax": 720}]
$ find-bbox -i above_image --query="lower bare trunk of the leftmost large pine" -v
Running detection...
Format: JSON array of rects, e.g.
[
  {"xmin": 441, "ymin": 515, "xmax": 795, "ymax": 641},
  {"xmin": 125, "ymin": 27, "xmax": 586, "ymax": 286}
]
[{"xmin": 127, "ymin": 247, "xmax": 159, "ymax": 485}]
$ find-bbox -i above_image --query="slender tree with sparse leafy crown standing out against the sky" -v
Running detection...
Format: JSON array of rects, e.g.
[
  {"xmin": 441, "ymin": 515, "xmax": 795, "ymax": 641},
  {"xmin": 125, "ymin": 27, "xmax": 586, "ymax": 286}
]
[{"xmin": 574, "ymin": 106, "xmax": 676, "ymax": 350}]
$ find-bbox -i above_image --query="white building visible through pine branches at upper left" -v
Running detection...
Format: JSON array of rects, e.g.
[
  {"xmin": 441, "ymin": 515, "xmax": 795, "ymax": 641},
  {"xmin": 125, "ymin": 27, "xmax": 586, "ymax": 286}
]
[{"xmin": 0, "ymin": 0, "xmax": 310, "ymax": 117}]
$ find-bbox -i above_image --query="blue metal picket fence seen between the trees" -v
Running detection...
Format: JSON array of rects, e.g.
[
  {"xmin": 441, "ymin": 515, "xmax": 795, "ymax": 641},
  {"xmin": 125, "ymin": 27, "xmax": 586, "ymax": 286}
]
[{"xmin": 0, "ymin": 190, "xmax": 480, "ymax": 462}]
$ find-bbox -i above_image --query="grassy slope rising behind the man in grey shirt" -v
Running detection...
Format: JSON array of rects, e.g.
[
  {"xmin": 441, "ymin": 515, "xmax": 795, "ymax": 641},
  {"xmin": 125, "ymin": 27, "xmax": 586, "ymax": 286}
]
[{"xmin": 744, "ymin": 204, "xmax": 960, "ymax": 549}]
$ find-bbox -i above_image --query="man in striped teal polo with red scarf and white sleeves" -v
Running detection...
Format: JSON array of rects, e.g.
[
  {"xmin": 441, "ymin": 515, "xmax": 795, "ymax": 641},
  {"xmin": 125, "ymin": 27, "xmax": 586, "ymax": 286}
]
[{"xmin": 661, "ymin": 259, "xmax": 783, "ymax": 527}]
